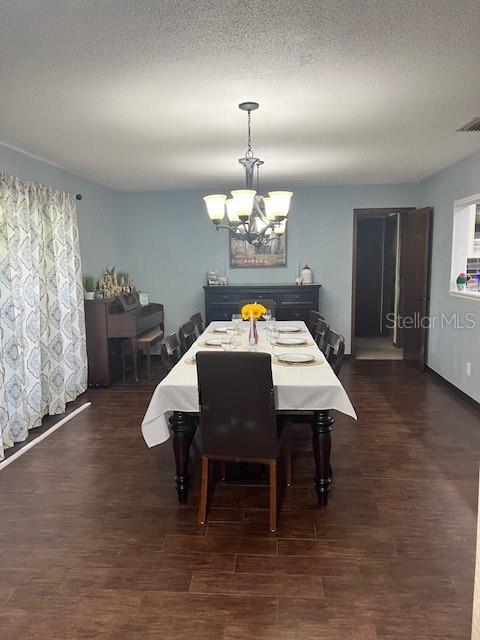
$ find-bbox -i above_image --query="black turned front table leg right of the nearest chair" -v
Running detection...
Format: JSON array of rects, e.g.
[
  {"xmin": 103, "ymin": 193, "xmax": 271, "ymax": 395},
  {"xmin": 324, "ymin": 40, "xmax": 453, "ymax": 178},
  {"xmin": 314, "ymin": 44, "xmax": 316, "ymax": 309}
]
[{"xmin": 311, "ymin": 410, "xmax": 335, "ymax": 505}]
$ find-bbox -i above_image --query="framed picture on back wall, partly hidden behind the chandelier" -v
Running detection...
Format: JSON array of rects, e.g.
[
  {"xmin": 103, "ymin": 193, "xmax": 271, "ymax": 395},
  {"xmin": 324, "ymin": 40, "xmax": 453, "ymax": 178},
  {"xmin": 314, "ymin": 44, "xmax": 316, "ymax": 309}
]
[{"xmin": 229, "ymin": 231, "xmax": 287, "ymax": 269}]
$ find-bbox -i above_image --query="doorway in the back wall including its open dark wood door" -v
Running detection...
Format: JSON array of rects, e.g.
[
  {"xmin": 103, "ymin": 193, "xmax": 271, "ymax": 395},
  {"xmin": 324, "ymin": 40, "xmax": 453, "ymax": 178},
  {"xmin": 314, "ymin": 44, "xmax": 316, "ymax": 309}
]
[{"xmin": 352, "ymin": 207, "xmax": 433, "ymax": 370}]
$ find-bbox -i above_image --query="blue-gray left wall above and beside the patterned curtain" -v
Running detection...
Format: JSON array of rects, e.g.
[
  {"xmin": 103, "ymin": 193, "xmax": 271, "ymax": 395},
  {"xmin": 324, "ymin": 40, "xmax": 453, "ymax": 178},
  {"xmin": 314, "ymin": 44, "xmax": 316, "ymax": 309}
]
[{"xmin": 0, "ymin": 145, "xmax": 121, "ymax": 275}]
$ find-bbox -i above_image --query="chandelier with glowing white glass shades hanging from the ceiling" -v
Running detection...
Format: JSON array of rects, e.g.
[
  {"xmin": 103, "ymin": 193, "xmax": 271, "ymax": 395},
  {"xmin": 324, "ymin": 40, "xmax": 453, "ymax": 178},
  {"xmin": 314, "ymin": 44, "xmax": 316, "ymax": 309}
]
[{"xmin": 203, "ymin": 102, "xmax": 293, "ymax": 247}]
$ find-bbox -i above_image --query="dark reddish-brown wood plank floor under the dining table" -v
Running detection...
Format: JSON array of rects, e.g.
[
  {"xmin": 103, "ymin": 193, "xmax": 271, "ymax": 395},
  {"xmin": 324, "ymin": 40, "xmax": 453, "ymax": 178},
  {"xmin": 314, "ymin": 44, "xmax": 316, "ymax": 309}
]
[{"xmin": 0, "ymin": 361, "xmax": 480, "ymax": 640}]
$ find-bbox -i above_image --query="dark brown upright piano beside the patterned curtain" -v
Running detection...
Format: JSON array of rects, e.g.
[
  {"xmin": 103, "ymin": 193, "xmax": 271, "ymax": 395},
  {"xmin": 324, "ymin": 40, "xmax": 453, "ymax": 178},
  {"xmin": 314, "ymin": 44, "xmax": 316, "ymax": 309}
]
[{"xmin": 85, "ymin": 294, "xmax": 164, "ymax": 387}]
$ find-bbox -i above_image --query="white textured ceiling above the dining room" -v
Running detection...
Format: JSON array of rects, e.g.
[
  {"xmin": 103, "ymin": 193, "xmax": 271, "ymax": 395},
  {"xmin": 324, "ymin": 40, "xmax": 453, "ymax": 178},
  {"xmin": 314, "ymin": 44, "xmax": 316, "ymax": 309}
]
[{"xmin": 0, "ymin": 0, "xmax": 480, "ymax": 190}]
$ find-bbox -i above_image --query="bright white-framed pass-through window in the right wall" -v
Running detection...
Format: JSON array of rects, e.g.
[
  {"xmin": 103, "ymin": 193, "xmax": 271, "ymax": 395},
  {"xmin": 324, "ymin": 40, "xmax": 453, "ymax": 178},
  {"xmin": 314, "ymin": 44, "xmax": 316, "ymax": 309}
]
[{"xmin": 450, "ymin": 194, "xmax": 480, "ymax": 298}]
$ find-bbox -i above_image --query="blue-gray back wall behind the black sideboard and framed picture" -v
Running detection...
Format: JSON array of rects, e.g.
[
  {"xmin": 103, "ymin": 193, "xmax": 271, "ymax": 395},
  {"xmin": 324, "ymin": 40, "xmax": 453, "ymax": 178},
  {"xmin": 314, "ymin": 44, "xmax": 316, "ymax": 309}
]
[{"xmin": 118, "ymin": 184, "xmax": 418, "ymax": 351}]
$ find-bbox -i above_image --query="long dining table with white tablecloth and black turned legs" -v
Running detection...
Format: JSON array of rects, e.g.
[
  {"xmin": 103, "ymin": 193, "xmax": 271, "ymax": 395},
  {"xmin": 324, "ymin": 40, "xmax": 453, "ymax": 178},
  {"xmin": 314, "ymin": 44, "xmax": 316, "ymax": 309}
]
[{"xmin": 142, "ymin": 321, "xmax": 356, "ymax": 505}]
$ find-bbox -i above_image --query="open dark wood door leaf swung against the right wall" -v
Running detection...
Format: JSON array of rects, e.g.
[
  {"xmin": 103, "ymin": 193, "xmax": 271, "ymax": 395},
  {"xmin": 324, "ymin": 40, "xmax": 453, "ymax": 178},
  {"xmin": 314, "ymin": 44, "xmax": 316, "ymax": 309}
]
[{"xmin": 401, "ymin": 207, "xmax": 432, "ymax": 371}]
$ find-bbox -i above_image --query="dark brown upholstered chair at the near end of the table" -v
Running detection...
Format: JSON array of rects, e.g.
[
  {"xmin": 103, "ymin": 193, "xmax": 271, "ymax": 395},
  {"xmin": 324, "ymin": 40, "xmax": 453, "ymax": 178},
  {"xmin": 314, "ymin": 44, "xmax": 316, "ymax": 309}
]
[{"xmin": 196, "ymin": 351, "xmax": 290, "ymax": 531}]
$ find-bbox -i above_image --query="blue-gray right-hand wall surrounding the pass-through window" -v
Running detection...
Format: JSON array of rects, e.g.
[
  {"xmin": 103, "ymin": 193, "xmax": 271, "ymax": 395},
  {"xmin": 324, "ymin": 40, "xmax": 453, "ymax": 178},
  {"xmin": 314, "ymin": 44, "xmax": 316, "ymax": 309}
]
[{"xmin": 419, "ymin": 154, "xmax": 480, "ymax": 402}]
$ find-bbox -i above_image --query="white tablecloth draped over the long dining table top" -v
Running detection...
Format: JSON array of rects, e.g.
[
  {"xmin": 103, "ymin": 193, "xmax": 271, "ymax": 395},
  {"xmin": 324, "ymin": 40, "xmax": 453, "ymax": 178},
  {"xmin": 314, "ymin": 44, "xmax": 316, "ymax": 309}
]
[{"xmin": 142, "ymin": 321, "xmax": 357, "ymax": 447}]
